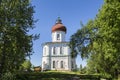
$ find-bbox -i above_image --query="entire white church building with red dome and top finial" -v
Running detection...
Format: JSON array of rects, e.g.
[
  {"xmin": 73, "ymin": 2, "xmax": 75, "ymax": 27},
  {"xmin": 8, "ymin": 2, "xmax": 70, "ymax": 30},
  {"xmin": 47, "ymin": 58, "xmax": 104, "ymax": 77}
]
[{"xmin": 41, "ymin": 18, "xmax": 76, "ymax": 71}]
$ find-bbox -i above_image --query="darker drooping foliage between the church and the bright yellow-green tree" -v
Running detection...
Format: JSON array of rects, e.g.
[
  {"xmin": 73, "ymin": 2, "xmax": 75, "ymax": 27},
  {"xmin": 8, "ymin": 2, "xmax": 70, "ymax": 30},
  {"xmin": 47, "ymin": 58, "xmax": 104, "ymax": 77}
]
[{"xmin": 69, "ymin": 20, "xmax": 96, "ymax": 58}]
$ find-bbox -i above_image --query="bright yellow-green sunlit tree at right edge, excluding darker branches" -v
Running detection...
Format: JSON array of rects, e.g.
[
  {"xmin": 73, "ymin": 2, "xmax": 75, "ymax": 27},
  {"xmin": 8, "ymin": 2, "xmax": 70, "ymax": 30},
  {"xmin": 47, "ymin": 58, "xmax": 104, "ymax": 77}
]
[{"xmin": 95, "ymin": 0, "xmax": 120, "ymax": 77}]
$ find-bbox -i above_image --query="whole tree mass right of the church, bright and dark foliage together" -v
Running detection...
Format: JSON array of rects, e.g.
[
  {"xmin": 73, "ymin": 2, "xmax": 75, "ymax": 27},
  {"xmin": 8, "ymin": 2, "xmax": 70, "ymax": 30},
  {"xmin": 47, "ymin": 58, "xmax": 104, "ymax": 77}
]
[{"xmin": 70, "ymin": 0, "xmax": 120, "ymax": 78}]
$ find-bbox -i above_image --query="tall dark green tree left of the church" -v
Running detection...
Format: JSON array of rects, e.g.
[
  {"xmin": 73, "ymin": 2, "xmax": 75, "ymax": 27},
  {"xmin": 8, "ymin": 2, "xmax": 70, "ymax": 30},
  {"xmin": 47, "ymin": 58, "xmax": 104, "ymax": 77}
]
[{"xmin": 0, "ymin": 0, "xmax": 35, "ymax": 77}]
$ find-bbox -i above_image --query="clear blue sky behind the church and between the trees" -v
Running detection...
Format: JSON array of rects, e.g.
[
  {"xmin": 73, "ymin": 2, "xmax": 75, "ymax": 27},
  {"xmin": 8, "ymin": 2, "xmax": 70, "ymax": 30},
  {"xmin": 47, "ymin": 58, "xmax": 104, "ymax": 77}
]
[{"xmin": 30, "ymin": 0, "xmax": 103, "ymax": 66}]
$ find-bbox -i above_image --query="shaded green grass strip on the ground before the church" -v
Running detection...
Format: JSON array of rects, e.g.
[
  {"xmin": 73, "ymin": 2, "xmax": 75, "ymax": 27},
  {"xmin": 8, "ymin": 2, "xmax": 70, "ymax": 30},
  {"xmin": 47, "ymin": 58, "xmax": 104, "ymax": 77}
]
[{"xmin": 17, "ymin": 72, "xmax": 100, "ymax": 80}]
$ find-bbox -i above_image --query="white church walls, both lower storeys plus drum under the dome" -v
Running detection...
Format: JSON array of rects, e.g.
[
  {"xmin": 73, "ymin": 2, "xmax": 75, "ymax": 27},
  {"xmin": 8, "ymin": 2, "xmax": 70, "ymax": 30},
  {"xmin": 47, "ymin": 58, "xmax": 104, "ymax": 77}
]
[{"xmin": 42, "ymin": 31, "xmax": 76, "ymax": 70}]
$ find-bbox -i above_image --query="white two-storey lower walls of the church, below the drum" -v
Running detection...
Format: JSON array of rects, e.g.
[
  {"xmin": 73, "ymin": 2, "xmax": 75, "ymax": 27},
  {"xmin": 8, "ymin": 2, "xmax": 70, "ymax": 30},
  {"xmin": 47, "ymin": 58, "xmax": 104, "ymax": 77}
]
[{"xmin": 42, "ymin": 42, "xmax": 75, "ymax": 70}]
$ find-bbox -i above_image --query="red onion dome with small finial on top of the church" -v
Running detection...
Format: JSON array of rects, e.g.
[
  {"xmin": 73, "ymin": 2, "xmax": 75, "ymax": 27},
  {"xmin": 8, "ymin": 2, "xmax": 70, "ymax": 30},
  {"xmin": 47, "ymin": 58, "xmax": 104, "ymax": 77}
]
[{"xmin": 52, "ymin": 18, "xmax": 67, "ymax": 33}]
